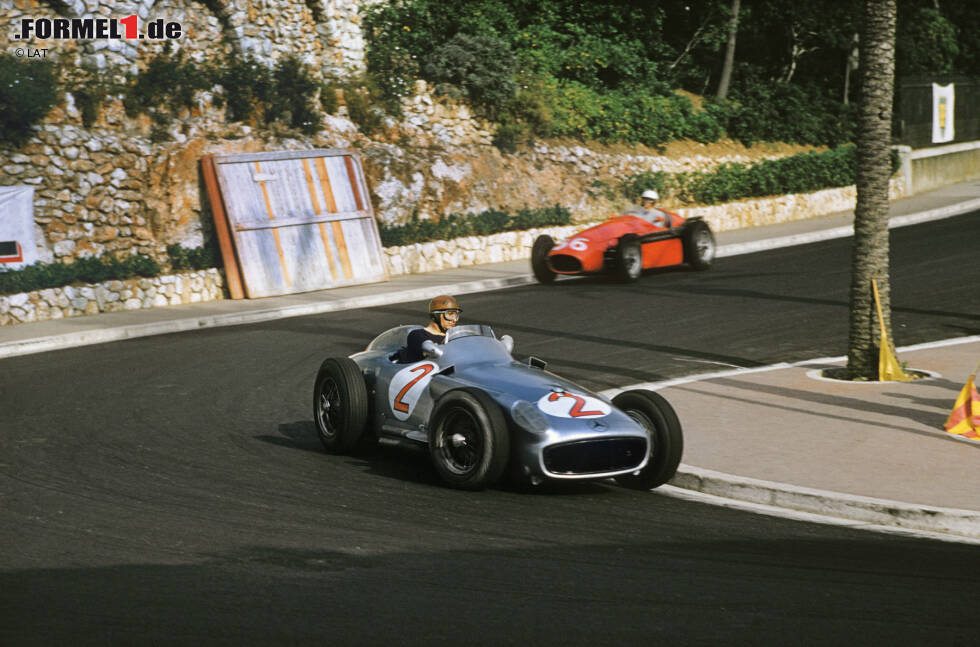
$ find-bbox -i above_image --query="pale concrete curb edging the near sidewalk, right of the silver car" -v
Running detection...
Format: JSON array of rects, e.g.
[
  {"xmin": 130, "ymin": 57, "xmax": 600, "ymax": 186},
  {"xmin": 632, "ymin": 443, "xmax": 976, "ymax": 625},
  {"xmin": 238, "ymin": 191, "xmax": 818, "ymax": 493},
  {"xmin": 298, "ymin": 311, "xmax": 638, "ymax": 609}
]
[{"xmin": 669, "ymin": 465, "xmax": 980, "ymax": 539}]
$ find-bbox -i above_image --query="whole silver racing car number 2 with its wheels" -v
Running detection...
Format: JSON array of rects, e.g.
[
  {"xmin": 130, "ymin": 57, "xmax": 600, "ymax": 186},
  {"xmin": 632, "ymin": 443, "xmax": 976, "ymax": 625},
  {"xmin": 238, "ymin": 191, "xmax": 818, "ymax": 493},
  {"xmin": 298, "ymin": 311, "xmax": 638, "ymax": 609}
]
[{"xmin": 313, "ymin": 324, "xmax": 683, "ymax": 490}]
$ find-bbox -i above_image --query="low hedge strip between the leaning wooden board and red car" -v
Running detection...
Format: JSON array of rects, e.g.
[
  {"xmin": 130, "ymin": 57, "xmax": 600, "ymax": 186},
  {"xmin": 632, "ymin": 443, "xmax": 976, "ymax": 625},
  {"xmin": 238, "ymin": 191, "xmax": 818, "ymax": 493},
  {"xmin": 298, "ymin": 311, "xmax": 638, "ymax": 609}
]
[{"xmin": 378, "ymin": 205, "xmax": 572, "ymax": 247}]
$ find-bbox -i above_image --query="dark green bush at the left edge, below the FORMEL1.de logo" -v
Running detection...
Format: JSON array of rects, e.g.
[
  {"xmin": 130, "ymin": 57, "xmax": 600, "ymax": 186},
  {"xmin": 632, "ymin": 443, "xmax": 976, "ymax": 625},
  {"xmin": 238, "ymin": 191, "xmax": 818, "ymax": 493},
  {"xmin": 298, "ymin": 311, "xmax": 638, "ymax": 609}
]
[{"xmin": 0, "ymin": 53, "xmax": 58, "ymax": 146}]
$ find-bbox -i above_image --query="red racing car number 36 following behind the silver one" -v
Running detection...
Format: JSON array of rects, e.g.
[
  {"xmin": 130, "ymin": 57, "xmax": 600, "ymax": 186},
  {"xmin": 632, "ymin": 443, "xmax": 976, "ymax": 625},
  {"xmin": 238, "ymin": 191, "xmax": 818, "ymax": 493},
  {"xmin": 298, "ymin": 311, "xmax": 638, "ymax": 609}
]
[{"xmin": 531, "ymin": 209, "xmax": 715, "ymax": 283}]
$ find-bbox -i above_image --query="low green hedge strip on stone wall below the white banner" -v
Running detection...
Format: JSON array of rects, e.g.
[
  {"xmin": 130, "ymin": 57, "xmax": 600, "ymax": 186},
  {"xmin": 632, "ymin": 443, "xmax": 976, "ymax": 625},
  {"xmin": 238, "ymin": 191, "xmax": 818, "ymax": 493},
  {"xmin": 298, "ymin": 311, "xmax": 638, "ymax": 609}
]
[{"xmin": 0, "ymin": 255, "xmax": 160, "ymax": 294}]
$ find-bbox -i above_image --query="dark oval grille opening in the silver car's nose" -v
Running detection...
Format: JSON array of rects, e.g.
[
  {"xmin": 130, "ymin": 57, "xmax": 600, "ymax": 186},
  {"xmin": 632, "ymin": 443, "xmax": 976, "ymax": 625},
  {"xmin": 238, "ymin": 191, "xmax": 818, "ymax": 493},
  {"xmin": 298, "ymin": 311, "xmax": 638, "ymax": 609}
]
[{"xmin": 544, "ymin": 438, "xmax": 647, "ymax": 475}]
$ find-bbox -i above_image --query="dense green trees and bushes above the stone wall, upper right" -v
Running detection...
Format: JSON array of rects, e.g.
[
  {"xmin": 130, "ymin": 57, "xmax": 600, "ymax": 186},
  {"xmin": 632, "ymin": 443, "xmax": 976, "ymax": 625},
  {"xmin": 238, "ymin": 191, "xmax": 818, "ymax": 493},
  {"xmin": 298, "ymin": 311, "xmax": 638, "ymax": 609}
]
[{"xmin": 365, "ymin": 0, "xmax": 980, "ymax": 148}]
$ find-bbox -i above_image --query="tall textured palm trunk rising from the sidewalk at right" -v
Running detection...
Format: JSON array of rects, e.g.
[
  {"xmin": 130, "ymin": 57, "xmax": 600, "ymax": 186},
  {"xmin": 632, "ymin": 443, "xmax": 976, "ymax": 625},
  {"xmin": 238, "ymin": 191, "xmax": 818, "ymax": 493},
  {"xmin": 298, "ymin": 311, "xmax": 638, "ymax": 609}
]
[{"xmin": 847, "ymin": 0, "xmax": 896, "ymax": 379}]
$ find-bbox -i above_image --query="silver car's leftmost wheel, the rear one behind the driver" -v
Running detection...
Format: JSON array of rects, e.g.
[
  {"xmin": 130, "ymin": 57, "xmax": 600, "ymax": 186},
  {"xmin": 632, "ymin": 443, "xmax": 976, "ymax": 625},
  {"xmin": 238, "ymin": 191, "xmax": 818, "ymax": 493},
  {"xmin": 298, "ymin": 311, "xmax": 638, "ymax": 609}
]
[{"xmin": 313, "ymin": 357, "xmax": 368, "ymax": 454}]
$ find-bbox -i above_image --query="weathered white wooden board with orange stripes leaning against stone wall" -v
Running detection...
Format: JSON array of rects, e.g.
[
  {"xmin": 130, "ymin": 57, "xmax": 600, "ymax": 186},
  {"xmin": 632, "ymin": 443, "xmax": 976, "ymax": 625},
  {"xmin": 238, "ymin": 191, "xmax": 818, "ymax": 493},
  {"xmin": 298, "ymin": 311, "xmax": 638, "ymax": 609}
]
[{"xmin": 206, "ymin": 150, "xmax": 388, "ymax": 299}]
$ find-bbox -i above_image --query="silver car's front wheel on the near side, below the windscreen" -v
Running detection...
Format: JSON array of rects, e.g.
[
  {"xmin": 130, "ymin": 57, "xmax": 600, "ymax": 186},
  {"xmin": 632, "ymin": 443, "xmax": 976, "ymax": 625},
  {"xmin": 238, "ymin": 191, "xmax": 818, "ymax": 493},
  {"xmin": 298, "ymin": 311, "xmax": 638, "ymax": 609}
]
[{"xmin": 429, "ymin": 389, "xmax": 510, "ymax": 490}]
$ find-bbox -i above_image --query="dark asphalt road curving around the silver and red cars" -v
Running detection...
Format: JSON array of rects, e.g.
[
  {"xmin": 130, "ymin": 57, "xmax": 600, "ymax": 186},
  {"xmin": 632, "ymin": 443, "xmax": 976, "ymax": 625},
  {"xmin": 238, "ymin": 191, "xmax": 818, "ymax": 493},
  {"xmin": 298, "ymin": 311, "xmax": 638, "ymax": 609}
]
[{"xmin": 0, "ymin": 214, "xmax": 980, "ymax": 646}]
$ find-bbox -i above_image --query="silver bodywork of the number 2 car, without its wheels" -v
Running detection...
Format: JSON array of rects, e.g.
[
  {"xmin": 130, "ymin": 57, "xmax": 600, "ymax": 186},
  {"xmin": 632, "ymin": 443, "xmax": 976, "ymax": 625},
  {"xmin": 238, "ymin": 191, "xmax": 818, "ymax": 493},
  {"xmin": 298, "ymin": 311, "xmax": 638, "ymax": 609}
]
[{"xmin": 351, "ymin": 325, "xmax": 649, "ymax": 479}]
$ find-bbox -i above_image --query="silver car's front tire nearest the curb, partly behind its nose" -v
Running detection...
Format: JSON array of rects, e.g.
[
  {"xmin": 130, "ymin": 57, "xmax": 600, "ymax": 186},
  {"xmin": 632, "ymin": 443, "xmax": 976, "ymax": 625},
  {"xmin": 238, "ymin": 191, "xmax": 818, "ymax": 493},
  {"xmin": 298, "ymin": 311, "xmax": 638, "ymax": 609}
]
[{"xmin": 613, "ymin": 389, "xmax": 684, "ymax": 490}]
